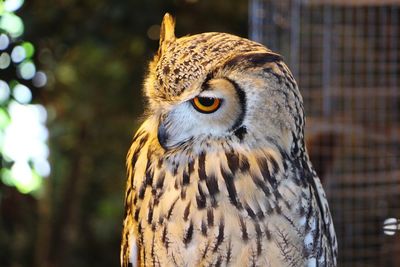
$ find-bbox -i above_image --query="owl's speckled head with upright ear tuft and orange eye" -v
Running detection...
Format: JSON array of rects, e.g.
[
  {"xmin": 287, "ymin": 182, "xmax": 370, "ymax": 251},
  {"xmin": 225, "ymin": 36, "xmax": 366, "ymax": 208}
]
[{"xmin": 145, "ymin": 14, "xmax": 304, "ymax": 156}]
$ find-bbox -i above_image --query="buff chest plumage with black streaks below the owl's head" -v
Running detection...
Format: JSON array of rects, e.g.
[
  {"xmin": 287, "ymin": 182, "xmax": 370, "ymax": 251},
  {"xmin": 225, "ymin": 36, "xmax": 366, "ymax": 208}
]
[{"xmin": 127, "ymin": 137, "xmax": 320, "ymax": 266}]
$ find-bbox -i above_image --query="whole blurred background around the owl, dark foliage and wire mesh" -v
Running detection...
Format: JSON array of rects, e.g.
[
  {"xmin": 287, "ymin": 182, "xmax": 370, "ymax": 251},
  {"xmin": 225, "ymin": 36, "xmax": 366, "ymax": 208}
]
[{"xmin": 0, "ymin": 0, "xmax": 400, "ymax": 267}]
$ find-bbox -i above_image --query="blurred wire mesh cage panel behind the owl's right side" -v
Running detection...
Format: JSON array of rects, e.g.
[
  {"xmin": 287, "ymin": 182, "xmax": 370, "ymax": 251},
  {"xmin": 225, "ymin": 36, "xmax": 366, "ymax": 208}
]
[{"xmin": 249, "ymin": 0, "xmax": 400, "ymax": 266}]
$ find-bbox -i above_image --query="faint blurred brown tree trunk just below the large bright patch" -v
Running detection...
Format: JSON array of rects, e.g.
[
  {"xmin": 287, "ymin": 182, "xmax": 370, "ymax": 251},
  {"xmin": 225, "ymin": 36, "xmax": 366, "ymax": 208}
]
[{"xmin": 36, "ymin": 123, "xmax": 87, "ymax": 267}]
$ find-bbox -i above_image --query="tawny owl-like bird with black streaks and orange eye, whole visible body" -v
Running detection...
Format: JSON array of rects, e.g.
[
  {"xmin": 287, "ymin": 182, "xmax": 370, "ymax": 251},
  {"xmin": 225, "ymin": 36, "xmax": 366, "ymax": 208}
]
[{"xmin": 121, "ymin": 14, "xmax": 337, "ymax": 267}]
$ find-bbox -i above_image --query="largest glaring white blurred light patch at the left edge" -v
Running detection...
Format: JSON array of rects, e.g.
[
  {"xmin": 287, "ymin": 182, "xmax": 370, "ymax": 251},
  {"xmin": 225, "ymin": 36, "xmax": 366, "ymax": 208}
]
[{"xmin": 0, "ymin": 101, "xmax": 51, "ymax": 193}]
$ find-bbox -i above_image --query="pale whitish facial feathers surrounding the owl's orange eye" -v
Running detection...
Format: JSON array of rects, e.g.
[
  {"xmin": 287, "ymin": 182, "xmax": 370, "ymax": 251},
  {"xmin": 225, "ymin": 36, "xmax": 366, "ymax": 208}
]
[{"xmin": 160, "ymin": 79, "xmax": 245, "ymax": 151}]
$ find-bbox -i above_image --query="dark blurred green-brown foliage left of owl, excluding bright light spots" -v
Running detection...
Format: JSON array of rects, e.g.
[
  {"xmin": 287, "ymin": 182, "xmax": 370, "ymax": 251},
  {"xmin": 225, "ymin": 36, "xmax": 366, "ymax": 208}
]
[{"xmin": 0, "ymin": 0, "xmax": 248, "ymax": 267}]
